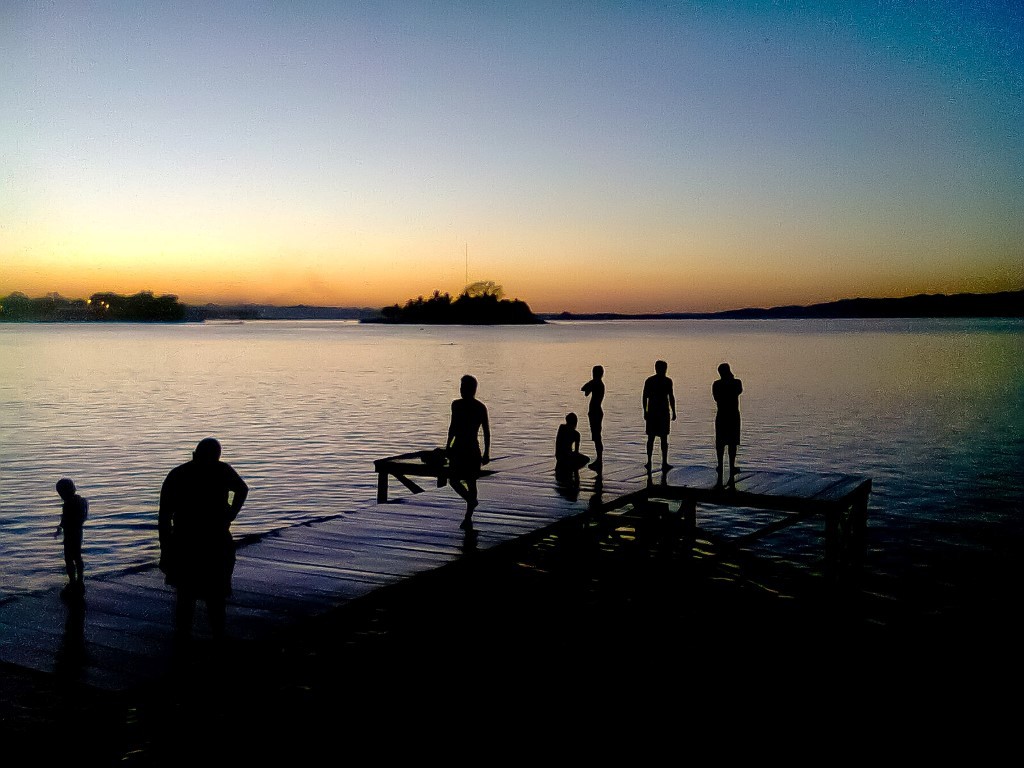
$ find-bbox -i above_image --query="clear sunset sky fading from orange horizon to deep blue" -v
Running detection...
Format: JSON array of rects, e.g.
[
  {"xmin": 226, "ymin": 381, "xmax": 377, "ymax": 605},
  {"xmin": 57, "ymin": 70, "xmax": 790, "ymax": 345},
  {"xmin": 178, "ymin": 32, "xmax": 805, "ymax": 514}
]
[{"xmin": 0, "ymin": 0, "xmax": 1024, "ymax": 312}]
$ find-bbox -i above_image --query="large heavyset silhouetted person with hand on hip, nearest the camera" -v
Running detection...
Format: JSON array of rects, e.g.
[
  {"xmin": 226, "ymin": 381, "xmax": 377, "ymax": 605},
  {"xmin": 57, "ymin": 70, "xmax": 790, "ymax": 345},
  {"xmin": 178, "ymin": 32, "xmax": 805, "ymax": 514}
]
[{"xmin": 159, "ymin": 437, "xmax": 249, "ymax": 638}]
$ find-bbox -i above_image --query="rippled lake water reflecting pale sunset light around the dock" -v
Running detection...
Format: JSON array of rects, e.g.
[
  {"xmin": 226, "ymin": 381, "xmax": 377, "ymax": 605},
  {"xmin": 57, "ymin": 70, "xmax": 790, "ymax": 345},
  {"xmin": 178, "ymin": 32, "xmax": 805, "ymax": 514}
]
[{"xmin": 0, "ymin": 319, "xmax": 1024, "ymax": 618}]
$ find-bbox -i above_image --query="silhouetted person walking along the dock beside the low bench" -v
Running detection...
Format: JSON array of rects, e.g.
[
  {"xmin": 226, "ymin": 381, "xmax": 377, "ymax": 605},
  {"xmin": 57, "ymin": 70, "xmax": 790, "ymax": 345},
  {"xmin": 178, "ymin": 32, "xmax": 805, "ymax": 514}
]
[{"xmin": 444, "ymin": 375, "xmax": 490, "ymax": 529}]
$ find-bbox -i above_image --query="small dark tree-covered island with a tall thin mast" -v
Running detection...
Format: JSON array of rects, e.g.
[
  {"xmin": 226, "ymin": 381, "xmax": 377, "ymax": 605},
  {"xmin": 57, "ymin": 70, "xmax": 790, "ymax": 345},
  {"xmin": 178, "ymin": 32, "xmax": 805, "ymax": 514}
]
[{"xmin": 359, "ymin": 281, "xmax": 545, "ymax": 326}]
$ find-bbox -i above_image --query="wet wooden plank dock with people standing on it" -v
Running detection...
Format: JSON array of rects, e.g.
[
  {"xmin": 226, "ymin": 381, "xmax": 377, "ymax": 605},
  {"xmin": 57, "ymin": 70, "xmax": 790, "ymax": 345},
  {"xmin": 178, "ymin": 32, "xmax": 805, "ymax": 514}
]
[{"xmin": 0, "ymin": 454, "xmax": 870, "ymax": 691}]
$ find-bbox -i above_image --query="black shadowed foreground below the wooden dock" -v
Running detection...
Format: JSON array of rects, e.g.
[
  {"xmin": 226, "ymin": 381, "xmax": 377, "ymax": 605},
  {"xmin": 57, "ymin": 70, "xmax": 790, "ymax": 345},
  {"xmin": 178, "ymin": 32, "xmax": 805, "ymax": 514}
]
[{"xmin": 0, "ymin": 524, "xmax": 1024, "ymax": 766}]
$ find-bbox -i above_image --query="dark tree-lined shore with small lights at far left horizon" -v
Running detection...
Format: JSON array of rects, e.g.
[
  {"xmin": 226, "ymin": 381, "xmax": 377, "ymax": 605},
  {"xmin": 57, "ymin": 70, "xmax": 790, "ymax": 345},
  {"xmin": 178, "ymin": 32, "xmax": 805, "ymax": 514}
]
[{"xmin": 0, "ymin": 291, "xmax": 187, "ymax": 323}]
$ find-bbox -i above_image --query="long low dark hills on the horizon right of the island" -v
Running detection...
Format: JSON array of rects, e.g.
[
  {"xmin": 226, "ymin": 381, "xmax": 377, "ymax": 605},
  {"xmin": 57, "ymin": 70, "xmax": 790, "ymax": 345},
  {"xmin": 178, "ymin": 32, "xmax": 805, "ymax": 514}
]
[{"xmin": 541, "ymin": 291, "xmax": 1024, "ymax": 319}]
